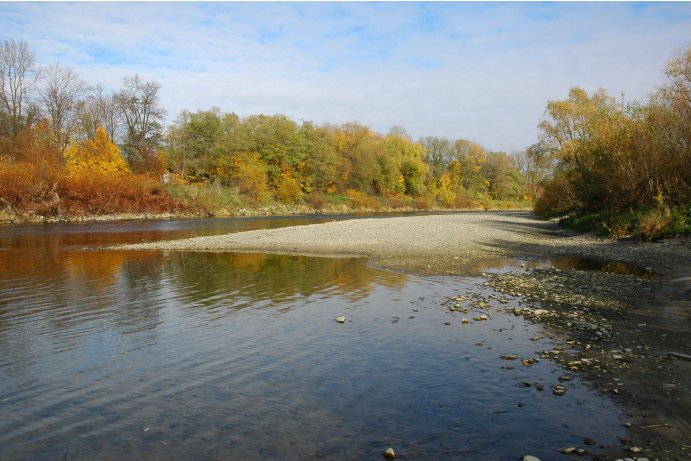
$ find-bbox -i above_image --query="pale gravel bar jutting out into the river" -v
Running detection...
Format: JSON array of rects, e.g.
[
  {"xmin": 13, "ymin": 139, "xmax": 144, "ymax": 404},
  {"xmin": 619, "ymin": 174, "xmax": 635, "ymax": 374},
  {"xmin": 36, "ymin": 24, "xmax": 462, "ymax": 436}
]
[{"xmin": 112, "ymin": 212, "xmax": 688, "ymax": 274}]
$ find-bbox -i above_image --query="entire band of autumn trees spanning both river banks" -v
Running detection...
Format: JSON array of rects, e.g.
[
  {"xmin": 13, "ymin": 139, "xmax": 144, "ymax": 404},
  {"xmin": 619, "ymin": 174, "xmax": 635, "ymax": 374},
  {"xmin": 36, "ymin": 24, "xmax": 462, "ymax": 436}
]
[{"xmin": 0, "ymin": 40, "xmax": 691, "ymax": 238}]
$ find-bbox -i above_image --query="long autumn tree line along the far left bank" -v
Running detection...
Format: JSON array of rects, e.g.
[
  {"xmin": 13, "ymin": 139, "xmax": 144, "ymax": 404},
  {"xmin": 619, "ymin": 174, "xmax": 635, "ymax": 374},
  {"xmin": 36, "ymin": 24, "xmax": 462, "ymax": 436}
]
[{"xmin": 0, "ymin": 40, "xmax": 526, "ymax": 213}]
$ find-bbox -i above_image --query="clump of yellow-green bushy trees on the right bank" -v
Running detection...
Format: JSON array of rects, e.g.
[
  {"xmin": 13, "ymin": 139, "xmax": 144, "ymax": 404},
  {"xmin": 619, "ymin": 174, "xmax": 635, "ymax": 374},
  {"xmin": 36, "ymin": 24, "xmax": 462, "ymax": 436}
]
[{"xmin": 527, "ymin": 49, "xmax": 691, "ymax": 239}]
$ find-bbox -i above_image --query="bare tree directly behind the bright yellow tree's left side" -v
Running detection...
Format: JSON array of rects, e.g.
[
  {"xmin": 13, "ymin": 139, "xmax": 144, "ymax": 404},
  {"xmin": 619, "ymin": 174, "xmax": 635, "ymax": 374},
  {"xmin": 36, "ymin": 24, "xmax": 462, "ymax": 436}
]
[{"xmin": 40, "ymin": 64, "xmax": 88, "ymax": 153}]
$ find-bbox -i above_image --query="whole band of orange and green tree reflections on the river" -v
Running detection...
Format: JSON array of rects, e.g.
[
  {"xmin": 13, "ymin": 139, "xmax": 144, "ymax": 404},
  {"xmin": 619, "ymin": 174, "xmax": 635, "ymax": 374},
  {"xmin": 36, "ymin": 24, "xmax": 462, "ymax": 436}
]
[{"xmin": 0, "ymin": 244, "xmax": 405, "ymax": 349}]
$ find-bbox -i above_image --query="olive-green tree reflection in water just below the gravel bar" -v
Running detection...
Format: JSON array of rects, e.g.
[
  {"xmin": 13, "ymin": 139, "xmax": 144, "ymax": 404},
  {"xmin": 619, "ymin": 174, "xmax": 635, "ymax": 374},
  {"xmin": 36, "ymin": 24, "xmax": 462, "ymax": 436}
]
[{"xmin": 166, "ymin": 252, "xmax": 405, "ymax": 308}]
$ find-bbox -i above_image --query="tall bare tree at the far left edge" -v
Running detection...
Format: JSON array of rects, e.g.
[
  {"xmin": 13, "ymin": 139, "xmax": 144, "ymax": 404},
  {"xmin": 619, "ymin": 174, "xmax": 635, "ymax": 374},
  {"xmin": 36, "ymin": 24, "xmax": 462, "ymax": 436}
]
[{"xmin": 0, "ymin": 40, "xmax": 40, "ymax": 136}]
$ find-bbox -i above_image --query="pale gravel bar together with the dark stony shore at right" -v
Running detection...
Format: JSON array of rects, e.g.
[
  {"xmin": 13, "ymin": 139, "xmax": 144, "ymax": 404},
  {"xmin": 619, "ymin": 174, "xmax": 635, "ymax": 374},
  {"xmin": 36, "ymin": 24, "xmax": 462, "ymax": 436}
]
[{"xmin": 119, "ymin": 212, "xmax": 691, "ymax": 460}]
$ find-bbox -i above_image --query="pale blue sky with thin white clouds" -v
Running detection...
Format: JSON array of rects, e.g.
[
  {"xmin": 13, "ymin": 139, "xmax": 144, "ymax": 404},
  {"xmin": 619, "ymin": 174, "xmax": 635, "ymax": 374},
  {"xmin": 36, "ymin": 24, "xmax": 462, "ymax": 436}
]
[{"xmin": 0, "ymin": 2, "xmax": 691, "ymax": 152}]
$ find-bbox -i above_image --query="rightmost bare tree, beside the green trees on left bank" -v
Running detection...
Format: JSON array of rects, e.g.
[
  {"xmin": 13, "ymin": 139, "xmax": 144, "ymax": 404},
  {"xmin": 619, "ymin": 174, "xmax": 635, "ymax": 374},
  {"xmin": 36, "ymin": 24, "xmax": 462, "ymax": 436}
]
[{"xmin": 115, "ymin": 74, "xmax": 165, "ymax": 171}]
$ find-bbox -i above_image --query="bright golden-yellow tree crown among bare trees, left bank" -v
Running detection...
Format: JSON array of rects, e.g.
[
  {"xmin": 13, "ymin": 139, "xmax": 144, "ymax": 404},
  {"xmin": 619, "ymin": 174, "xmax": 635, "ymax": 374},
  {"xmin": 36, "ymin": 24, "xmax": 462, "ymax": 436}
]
[{"xmin": 65, "ymin": 127, "xmax": 130, "ymax": 176}]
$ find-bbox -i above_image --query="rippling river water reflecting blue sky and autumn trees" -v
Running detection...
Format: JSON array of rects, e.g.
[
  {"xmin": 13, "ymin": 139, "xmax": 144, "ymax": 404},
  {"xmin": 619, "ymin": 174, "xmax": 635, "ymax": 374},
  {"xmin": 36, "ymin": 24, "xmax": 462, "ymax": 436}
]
[{"xmin": 0, "ymin": 216, "xmax": 623, "ymax": 460}]
